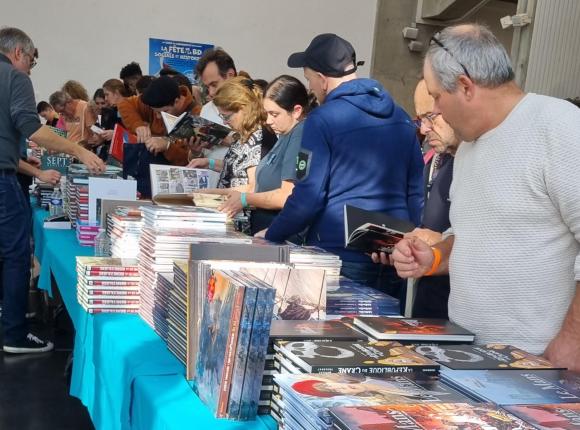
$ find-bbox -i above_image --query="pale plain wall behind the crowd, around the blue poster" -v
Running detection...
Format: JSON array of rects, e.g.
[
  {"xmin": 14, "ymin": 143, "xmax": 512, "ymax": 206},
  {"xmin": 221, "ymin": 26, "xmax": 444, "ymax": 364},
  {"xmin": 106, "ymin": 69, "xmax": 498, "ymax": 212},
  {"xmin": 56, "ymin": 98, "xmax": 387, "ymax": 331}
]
[{"xmin": 0, "ymin": 0, "xmax": 376, "ymax": 100}]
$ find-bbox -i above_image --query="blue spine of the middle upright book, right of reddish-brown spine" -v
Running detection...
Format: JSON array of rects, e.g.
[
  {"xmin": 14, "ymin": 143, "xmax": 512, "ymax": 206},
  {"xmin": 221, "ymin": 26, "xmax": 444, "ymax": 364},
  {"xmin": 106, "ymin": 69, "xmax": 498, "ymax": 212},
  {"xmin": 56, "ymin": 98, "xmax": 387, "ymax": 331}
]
[{"xmin": 227, "ymin": 286, "xmax": 257, "ymax": 419}]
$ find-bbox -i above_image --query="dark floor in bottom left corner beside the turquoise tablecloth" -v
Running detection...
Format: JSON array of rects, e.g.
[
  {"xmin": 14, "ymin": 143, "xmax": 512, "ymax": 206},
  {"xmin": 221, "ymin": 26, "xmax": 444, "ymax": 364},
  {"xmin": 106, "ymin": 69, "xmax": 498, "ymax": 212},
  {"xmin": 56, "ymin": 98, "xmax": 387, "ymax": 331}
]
[{"xmin": 0, "ymin": 310, "xmax": 93, "ymax": 430}]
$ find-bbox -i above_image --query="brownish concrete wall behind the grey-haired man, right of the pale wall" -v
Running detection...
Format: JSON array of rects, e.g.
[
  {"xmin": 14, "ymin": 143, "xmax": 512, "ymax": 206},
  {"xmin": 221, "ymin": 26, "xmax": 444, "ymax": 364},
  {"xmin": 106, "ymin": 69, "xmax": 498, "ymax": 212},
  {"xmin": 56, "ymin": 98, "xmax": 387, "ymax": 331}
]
[{"xmin": 371, "ymin": 0, "xmax": 516, "ymax": 115}]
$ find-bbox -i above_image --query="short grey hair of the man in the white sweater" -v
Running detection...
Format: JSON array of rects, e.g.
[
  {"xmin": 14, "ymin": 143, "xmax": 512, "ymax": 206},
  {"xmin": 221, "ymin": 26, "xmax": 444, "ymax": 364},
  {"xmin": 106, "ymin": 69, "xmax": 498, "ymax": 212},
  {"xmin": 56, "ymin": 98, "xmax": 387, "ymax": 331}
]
[{"xmin": 425, "ymin": 24, "xmax": 515, "ymax": 92}]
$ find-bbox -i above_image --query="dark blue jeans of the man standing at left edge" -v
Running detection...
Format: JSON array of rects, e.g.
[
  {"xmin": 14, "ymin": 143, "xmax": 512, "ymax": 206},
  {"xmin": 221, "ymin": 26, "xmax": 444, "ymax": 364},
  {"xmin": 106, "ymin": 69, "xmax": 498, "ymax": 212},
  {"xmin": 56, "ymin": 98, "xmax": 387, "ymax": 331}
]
[{"xmin": 0, "ymin": 172, "xmax": 32, "ymax": 344}]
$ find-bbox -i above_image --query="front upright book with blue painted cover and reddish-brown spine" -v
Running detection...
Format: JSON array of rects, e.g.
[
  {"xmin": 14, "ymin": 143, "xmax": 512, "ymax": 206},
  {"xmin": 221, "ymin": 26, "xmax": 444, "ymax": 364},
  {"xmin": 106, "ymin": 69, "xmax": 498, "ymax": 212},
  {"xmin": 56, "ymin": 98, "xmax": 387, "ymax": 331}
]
[{"xmin": 195, "ymin": 271, "xmax": 244, "ymax": 416}]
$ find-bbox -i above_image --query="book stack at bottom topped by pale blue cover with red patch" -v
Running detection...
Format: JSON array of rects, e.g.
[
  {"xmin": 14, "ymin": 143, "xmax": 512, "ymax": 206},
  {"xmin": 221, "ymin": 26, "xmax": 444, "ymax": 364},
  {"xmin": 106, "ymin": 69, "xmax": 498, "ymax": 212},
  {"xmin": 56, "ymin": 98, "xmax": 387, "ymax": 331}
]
[{"xmin": 273, "ymin": 373, "xmax": 469, "ymax": 429}]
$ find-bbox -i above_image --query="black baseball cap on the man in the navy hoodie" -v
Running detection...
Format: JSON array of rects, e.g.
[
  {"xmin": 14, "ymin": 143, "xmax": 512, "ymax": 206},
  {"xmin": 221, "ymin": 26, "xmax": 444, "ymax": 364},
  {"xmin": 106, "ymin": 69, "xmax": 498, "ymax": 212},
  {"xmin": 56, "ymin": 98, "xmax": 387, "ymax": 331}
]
[{"xmin": 288, "ymin": 33, "xmax": 364, "ymax": 78}]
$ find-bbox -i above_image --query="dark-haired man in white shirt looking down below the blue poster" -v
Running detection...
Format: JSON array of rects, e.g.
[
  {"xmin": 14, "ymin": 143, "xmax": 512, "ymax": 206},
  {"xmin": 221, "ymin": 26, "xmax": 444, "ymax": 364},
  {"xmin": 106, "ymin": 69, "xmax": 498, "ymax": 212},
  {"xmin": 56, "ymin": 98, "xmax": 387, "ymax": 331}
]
[{"xmin": 195, "ymin": 48, "xmax": 238, "ymax": 160}]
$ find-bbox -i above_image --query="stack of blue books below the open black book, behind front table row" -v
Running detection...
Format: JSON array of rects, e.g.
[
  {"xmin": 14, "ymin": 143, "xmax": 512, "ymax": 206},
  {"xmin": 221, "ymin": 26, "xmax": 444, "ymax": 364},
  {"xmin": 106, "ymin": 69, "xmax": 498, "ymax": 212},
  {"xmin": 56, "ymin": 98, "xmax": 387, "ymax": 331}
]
[{"xmin": 326, "ymin": 276, "xmax": 400, "ymax": 319}]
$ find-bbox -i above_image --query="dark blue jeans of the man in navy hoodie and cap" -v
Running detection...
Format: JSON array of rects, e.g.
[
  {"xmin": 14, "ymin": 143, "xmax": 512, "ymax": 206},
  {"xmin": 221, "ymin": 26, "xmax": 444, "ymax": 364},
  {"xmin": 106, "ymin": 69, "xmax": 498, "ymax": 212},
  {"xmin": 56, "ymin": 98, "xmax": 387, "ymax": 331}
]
[{"xmin": 340, "ymin": 261, "xmax": 407, "ymax": 315}]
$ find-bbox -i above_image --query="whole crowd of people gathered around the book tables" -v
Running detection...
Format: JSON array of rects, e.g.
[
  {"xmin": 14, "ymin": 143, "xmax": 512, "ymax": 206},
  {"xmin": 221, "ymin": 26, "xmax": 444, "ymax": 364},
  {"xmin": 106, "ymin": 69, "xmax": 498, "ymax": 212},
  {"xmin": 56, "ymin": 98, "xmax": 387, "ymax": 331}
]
[{"xmin": 0, "ymin": 24, "xmax": 580, "ymax": 370}]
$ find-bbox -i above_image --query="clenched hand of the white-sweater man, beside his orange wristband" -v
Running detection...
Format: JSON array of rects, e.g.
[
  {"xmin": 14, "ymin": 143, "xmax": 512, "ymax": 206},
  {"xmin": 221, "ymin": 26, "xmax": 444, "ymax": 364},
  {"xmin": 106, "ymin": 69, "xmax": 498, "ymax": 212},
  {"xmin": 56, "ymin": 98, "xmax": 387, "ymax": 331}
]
[{"xmin": 391, "ymin": 238, "xmax": 435, "ymax": 278}]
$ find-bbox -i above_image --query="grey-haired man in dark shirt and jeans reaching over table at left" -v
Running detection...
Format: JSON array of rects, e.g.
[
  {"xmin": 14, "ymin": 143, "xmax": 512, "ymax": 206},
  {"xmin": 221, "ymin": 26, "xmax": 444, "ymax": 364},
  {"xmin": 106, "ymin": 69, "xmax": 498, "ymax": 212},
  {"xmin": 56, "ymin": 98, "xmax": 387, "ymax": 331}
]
[{"xmin": 0, "ymin": 27, "xmax": 105, "ymax": 353}]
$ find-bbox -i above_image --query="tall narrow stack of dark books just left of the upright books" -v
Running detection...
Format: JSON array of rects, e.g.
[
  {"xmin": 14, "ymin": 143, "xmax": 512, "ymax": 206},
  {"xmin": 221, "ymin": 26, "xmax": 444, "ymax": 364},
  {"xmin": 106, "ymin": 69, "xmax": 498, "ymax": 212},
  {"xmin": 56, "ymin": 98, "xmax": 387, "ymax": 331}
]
[{"xmin": 167, "ymin": 261, "xmax": 189, "ymax": 365}]
